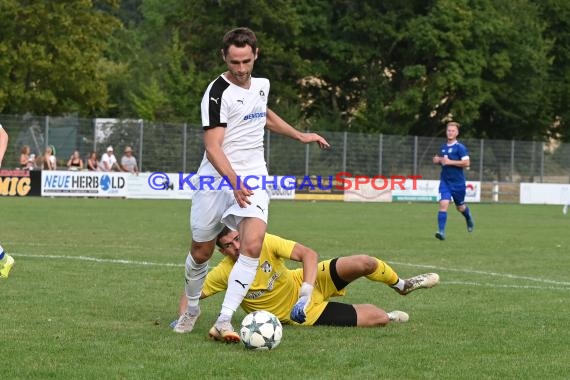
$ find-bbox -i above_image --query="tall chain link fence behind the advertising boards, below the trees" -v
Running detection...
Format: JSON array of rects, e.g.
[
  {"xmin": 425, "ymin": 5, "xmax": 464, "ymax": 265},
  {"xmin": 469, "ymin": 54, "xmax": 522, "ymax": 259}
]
[{"xmin": 0, "ymin": 115, "xmax": 570, "ymax": 184}]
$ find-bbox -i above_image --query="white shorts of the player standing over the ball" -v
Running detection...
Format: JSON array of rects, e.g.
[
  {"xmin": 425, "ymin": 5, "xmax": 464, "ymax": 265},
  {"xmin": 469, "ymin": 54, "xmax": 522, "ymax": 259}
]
[{"xmin": 190, "ymin": 183, "xmax": 269, "ymax": 242}]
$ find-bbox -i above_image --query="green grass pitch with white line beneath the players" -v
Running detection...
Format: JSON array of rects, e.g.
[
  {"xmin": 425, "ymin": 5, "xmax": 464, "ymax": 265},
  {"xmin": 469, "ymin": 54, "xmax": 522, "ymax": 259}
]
[{"xmin": 0, "ymin": 198, "xmax": 570, "ymax": 379}]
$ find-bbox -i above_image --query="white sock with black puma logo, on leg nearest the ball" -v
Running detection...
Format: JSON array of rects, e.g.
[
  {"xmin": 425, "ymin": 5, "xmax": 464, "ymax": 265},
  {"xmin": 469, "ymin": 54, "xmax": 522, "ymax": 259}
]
[{"xmin": 218, "ymin": 255, "xmax": 259, "ymax": 320}]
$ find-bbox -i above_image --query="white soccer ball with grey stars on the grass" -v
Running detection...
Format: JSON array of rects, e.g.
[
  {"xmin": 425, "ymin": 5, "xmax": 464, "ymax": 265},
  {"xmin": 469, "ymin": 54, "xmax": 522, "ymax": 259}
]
[{"xmin": 240, "ymin": 310, "xmax": 283, "ymax": 350}]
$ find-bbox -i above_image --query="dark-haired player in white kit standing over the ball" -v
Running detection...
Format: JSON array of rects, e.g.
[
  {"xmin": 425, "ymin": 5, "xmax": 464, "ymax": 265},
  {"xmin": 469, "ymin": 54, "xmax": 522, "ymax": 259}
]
[{"xmin": 174, "ymin": 28, "xmax": 329, "ymax": 343}]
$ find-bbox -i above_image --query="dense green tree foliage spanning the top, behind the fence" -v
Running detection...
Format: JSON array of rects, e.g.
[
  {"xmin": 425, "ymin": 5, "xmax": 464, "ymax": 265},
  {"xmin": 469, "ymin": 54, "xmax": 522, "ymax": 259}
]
[{"xmin": 0, "ymin": 0, "xmax": 570, "ymax": 140}]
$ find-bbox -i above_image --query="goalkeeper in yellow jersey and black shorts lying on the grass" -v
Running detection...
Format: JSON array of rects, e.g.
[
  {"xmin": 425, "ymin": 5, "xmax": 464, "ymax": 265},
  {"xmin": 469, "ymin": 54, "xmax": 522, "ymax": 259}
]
[{"xmin": 174, "ymin": 228, "xmax": 439, "ymax": 327}]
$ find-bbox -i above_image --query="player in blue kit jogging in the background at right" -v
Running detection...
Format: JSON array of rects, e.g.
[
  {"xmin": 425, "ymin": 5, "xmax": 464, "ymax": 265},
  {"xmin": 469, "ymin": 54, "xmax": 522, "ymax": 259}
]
[{"xmin": 433, "ymin": 121, "xmax": 475, "ymax": 240}]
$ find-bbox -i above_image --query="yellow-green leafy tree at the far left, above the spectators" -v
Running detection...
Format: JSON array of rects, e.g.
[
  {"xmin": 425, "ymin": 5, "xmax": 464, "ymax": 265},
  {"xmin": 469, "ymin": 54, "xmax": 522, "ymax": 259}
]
[{"xmin": 0, "ymin": 0, "xmax": 120, "ymax": 115}]
